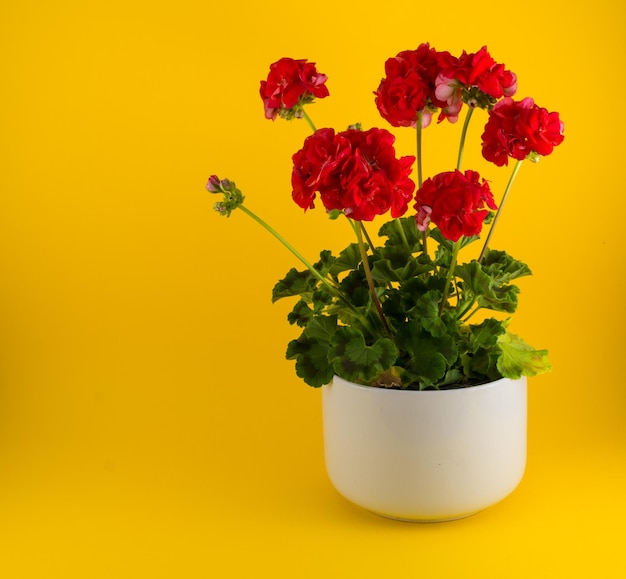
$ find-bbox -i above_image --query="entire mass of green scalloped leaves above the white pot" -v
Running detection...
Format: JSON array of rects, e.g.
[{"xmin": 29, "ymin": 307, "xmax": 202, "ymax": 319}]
[{"xmin": 272, "ymin": 216, "xmax": 550, "ymax": 390}]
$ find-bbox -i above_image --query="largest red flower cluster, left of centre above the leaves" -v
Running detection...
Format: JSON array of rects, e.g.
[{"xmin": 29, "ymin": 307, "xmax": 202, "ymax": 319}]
[{"xmin": 291, "ymin": 128, "xmax": 415, "ymax": 221}]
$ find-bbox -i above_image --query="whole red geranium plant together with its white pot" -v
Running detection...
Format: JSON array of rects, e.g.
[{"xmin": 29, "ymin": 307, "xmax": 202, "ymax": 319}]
[{"xmin": 207, "ymin": 43, "xmax": 563, "ymax": 520}]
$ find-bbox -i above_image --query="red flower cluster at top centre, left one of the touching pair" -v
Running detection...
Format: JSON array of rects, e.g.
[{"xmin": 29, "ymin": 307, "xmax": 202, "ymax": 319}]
[{"xmin": 374, "ymin": 43, "xmax": 461, "ymax": 127}]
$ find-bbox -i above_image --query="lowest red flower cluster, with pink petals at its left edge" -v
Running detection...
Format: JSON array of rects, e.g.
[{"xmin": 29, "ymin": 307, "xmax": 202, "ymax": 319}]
[{"xmin": 414, "ymin": 170, "xmax": 497, "ymax": 241}]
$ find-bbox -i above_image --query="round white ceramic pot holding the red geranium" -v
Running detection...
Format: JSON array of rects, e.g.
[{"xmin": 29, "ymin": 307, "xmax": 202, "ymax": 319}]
[{"xmin": 322, "ymin": 377, "xmax": 527, "ymax": 521}]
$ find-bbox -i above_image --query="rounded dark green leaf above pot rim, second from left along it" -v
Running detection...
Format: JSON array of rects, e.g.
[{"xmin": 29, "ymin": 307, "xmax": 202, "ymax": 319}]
[{"xmin": 329, "ymin": 327, "xmax": 398, "ymax": 384}]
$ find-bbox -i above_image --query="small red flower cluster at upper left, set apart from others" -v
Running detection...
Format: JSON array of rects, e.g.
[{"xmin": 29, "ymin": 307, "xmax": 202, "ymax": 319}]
[{"xmin": 260, "ymin": 58, "xmax": 328, "ymax": 120}]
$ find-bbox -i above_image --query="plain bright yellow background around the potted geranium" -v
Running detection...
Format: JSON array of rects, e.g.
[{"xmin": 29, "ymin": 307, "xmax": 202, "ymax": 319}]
[{"xmin": 0, "ymin": 0, "xmax": 626, "ymax": 579}]
